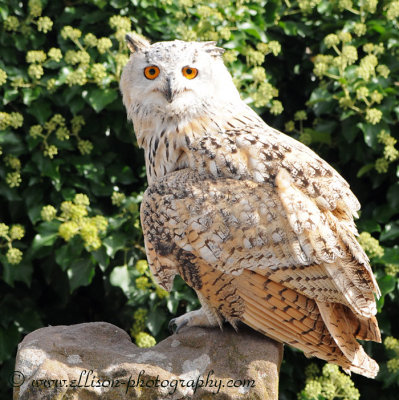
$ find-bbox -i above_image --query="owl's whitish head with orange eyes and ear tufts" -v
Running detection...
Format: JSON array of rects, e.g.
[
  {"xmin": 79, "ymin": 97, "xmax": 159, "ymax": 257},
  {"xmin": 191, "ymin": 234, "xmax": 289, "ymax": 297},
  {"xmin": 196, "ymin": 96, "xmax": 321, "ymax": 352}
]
[{"xmin": 120, "ymin": 35, "xmax": 240, "ymax": 119}]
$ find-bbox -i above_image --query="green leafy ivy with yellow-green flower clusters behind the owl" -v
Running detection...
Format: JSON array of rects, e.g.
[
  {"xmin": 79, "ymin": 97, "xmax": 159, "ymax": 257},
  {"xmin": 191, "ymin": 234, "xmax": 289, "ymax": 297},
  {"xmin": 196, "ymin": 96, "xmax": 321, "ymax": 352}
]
[{"xmin": 0, "ymin": 0, "xmax": 399, "ymax": 400}]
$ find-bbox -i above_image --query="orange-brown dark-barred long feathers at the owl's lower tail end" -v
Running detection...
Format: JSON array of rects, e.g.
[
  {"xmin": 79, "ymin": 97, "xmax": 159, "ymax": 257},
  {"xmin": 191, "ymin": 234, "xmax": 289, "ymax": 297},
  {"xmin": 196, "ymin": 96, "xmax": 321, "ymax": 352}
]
[{"xmin": 235, "ymin": 270, "xmax": 378, "ymax": 378}]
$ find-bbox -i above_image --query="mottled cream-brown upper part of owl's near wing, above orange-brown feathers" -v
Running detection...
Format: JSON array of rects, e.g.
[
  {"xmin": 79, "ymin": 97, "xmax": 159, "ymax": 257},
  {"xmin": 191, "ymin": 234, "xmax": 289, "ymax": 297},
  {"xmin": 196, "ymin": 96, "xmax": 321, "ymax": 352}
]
[{"xmin": 143, "ymin": 170, "xmax": 378, "ymax": 318}]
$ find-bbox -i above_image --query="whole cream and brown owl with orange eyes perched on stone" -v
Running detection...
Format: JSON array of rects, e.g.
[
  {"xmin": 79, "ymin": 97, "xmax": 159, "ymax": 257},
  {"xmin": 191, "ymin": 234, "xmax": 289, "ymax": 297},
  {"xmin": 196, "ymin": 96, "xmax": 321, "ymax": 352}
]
[{"xmin": 120, "ymin": 35, "xmax": 381, "ymax": 377}]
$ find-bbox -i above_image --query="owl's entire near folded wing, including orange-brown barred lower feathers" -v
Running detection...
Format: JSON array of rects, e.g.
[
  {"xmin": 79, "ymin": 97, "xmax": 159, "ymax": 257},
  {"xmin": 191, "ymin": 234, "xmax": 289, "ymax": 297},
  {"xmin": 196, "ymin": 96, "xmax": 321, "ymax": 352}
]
[{"xmin": 142, "ymin": 169, "xmax": 380, "ymax": 376}]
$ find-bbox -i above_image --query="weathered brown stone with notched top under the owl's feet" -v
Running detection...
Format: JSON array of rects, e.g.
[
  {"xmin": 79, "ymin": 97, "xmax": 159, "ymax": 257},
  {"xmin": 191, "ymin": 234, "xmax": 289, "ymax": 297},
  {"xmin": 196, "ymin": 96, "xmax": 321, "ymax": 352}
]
[{"xmin": 13, "ymin": 322, "xmax": 282, "ymax": 400}]
